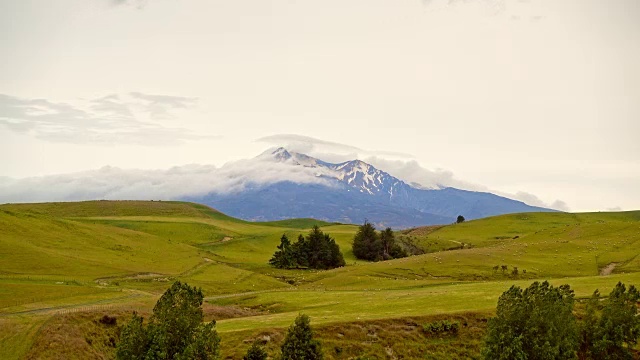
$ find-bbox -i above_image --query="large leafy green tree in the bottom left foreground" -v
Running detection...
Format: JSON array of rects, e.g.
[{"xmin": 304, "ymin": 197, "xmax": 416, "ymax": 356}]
[{"xmin": 116, "ymin": 281, "xmax": 220, "ymax": 360}]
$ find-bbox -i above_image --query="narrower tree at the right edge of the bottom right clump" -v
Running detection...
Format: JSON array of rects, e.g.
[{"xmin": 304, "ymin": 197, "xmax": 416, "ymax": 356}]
[{"xmin": 579, "ymin": 282, "xmax": 640, "ymax": 359}]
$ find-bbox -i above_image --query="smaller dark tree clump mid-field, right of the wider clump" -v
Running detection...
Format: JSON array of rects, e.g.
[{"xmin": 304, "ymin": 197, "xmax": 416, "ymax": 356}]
[{"xmin": 353, "ymin": 221, "xmax": 407, "ymax": 261}]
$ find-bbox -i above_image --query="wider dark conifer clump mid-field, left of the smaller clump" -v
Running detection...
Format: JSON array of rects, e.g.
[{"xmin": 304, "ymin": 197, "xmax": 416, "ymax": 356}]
[{"xmin": 269, "ymin": 226, "xmax": 345, "ymax": 269}]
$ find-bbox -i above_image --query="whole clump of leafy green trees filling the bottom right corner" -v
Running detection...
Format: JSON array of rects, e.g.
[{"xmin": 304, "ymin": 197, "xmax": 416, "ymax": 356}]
[{"xmin": 482, "ymin": 281, "xmax": 640, "ymax": 359}]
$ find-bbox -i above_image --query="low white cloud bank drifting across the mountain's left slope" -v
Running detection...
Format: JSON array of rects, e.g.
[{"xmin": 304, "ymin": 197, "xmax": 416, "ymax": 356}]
[{"xmin": 0, "ymin": 157, "xmax": 338, "ymax": 203}]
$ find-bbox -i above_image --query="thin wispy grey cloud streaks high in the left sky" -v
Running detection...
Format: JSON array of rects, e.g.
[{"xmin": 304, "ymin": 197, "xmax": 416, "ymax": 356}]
[{"xmin": 0, "ymin": 93, "xmax": 214, "ymax": 146}]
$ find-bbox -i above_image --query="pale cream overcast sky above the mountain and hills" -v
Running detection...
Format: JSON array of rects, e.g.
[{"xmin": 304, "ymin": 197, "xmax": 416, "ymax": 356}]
[{"xmin": 0, "ymin": 0, "xmax": 640, "ymax": 211}]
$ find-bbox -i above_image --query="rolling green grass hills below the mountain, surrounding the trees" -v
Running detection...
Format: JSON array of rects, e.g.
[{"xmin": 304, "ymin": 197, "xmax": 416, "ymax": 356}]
[{"xmin": 0, "ymin": 201, "xmax": 640, "ymax": 359}]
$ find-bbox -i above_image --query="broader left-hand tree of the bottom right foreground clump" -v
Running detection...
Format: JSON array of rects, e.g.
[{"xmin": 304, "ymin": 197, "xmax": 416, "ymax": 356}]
[{"xmin": 482, "ymin": 281, "xmax": 578, "ymax": 360}]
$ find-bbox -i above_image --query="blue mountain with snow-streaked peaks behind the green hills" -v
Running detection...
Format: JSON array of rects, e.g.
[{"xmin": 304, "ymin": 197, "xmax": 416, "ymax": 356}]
[{"xmin": 185, "ymin": 148, "xmax": 553, "ymax": 228}]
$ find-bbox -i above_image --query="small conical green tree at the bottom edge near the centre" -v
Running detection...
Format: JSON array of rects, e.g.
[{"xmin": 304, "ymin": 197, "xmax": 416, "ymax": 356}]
[{"xmin": 280, "ymin": 314, "xmax": 323, "ymax": 360}]
